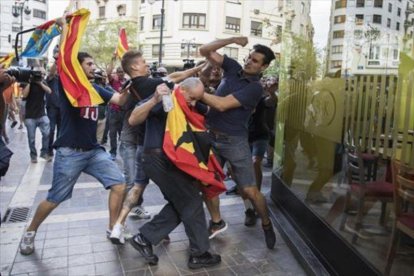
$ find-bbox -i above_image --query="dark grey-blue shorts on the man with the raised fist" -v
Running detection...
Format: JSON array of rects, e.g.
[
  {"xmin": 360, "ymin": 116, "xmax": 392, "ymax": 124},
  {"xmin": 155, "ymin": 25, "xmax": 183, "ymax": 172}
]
[{"xmin": 210, "ymin": 133, "xmax": 256, "ymax": 188}]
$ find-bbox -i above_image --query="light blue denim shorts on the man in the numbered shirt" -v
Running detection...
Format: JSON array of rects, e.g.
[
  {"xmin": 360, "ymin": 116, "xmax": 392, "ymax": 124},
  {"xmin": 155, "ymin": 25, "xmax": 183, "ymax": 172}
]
[{"xmin": 47, "ymin": 147, "xmax": 125, "ymax": 204}]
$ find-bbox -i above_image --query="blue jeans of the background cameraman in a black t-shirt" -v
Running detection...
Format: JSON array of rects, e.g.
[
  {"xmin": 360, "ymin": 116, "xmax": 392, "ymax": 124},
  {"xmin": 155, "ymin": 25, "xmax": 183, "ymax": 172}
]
[{"xmin": 24, "ymin": 115, "xmax": 50, "ymax": 159}]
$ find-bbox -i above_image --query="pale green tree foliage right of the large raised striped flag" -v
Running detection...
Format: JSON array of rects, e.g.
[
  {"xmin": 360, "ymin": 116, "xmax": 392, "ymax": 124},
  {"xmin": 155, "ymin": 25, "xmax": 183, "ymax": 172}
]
[{"xmin": 81, "ymin": 20, "xmax": 138, "ymax": 69}]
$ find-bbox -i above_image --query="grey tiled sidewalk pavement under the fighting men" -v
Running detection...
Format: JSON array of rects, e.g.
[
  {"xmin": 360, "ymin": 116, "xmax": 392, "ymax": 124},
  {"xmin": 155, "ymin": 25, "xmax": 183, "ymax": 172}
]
[{"xmin": 0, "ymin": 127, "xmax": 306, "ymax": 276}]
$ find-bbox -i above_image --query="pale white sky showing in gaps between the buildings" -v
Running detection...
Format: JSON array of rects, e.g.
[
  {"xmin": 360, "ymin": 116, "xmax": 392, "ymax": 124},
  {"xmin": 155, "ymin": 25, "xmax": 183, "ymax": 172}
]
[{"xmin": 49, "ymin": 0, "xmax": 332, "ymax": 48}]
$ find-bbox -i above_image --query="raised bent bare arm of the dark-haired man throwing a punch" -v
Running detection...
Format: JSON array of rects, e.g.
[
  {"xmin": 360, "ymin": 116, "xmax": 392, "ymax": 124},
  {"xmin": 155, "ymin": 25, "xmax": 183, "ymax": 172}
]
[{"xmin": 200, "ymin": 36, "xmax": 248, "ymax": 66}]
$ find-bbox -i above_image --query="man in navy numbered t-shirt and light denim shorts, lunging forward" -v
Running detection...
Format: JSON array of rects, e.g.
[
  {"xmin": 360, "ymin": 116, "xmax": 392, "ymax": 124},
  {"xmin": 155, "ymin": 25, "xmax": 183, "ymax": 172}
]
[{"xmin": 20, "ymin": 52, "xmax": 128, "ymax": 255}]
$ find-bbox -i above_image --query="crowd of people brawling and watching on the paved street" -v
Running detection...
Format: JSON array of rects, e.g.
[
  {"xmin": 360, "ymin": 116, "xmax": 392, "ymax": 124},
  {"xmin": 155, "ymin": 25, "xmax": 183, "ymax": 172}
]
[{"xmin": 0, "ymin": 14, "xmax": 277, "ymax": 269}]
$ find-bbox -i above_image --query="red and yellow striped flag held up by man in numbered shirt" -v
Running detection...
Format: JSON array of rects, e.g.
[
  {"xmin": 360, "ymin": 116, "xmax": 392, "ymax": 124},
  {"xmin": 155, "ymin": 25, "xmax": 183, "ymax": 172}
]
[{"xmin": 58, "ymin": 9, "xmax": 103, "ymax": 107}]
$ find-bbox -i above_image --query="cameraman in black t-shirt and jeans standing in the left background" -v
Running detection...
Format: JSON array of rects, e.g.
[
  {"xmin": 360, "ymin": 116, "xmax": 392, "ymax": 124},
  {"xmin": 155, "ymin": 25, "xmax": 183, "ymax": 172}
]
[{"xmin": 22, "ymin": 67, "xmax": 52, "ymax": 163}]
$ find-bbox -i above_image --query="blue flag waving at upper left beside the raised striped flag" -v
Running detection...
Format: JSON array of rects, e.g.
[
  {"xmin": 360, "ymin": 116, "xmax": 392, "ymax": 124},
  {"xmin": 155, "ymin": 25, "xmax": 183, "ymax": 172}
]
[{"xmin": 20, "ymin": 19, "xmax": 60, "ymax": 58}]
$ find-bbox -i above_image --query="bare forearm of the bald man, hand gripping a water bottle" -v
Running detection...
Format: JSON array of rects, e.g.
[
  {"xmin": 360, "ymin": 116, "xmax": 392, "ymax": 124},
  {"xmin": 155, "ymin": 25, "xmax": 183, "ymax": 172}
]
[{"xmin": 128, "ymin": 83, "xmax": 169, "ymax": 126}]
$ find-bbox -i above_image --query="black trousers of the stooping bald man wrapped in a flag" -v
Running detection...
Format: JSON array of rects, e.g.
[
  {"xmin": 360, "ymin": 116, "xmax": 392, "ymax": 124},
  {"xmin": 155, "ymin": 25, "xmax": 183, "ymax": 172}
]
[{"xmin": 140, "ymin": 153, "xmax": 210, "ymax": 256}]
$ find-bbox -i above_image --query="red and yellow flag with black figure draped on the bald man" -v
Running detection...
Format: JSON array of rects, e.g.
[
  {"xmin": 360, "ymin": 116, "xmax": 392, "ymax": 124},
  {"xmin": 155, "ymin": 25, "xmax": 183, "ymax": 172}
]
[{"xmin": 163, "ymin": 87, "xmax": 226, "ymax": 198}]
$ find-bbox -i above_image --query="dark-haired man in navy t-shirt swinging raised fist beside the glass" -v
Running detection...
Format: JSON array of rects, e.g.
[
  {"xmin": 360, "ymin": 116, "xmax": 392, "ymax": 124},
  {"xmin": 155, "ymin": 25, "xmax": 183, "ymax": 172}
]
[{"xmin": 200, "ymin": 37, "xmax": 276, "ymax": 249}]
